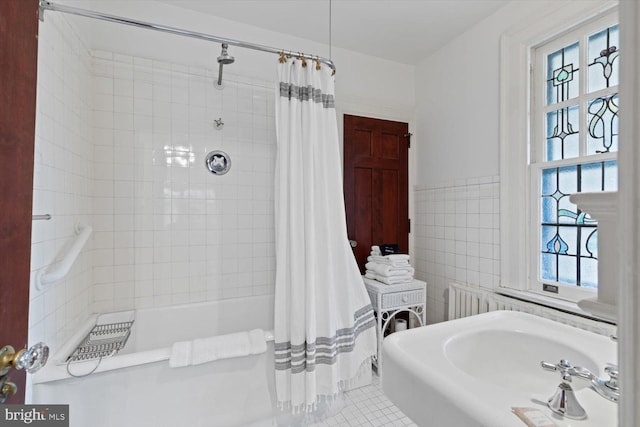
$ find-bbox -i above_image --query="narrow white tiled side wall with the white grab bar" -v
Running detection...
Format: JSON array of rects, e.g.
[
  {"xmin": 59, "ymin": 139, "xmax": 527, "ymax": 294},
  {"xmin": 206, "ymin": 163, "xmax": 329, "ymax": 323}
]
[{"xmin": 29, "ymin": 14, "xmax": 94, "ymax": 349}]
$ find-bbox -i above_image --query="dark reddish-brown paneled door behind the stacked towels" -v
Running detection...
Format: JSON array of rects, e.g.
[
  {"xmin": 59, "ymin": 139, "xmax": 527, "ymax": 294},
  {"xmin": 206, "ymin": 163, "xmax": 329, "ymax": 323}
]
[{"xmin": 344, "ymin": 114, "xmax": 409, "ymax": 272}]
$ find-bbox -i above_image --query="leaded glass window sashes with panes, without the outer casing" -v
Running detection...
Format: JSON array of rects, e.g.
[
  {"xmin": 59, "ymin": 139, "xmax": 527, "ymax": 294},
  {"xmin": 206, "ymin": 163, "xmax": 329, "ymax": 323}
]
[{"xmin": 532, "ymin": 19, "xmax": 620, "ymax": 289}]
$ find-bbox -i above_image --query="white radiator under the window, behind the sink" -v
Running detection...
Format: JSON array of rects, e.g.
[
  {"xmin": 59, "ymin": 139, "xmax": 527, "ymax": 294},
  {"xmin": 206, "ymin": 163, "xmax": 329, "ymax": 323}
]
[{"xmin": 448, "ymin": 283, "xmax": 616, "ymax": 336}]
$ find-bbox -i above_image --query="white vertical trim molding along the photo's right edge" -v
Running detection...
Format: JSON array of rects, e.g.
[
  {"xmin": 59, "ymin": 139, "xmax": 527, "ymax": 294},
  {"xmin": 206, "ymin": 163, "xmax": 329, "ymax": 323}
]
[{"xmin": 618, "ymin": 0, "xmax": 640, "ymax": 427}]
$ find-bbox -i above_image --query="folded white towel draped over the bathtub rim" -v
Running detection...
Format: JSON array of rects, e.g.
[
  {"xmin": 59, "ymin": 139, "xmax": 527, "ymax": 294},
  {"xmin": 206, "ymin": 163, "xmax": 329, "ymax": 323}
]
[{"xmin": 169, "ymin": 329, "xmax": 267, "ymax": 368}]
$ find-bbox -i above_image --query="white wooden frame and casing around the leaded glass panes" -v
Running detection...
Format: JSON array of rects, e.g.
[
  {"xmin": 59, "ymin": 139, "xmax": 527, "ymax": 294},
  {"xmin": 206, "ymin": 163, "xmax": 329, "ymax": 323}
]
[{"xmin": 494, "ymin": 1, "xmax": 619, "ymax": 314}]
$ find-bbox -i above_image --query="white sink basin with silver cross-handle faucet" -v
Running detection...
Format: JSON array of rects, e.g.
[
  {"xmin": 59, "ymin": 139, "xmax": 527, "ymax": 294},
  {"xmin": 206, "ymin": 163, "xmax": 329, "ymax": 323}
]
[{"xmin": 382, "ymin": 311, "xmax": 618, "ymax": 427}]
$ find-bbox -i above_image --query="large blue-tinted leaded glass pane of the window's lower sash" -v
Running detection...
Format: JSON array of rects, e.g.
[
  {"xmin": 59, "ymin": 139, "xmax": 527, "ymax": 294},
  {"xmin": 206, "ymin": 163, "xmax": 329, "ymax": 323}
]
[{"xmin": 540, "ymin": 160, "xmax": 617, "ymax": 288}]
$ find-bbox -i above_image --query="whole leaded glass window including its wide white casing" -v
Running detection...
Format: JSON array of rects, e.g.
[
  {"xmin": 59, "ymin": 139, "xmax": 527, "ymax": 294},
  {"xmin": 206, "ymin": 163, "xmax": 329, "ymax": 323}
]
[{"xmin": 497, "ymin": 3, "xmax": 624, "ymax": 311}]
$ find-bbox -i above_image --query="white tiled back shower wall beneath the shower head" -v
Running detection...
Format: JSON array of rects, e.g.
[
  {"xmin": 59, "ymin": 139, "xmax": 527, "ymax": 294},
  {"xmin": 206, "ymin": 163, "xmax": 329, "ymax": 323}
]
[{"xmin": 92, "ymin": 51, "xmax": 275, "ymax": 312}]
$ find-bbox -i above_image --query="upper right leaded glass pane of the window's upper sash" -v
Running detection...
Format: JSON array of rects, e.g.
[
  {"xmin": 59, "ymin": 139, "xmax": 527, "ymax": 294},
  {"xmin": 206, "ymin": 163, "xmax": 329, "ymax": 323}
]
[{"xmin": 587, "ymin": 25, "xmax": 620, "ymax": 92}]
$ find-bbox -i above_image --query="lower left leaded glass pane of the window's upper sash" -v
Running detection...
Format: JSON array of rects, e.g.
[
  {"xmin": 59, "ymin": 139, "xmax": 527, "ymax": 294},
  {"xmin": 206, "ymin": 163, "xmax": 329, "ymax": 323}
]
[{"xmin": 546, "ymin": 105, "xmax": 580, "ymax": 161}]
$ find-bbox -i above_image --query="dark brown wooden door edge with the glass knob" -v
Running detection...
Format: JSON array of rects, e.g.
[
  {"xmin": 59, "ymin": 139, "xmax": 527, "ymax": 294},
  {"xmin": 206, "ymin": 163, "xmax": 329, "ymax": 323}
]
[{"xmin": 0, "ymin": 0, "xmax": 38, "ymax": 403}]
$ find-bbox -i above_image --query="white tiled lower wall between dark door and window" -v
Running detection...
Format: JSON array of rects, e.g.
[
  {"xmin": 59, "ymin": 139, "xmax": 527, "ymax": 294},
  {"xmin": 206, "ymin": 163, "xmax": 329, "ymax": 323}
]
[{"xmin": 413, "ymin": 176, "xmax": 500, "ymax": 323}]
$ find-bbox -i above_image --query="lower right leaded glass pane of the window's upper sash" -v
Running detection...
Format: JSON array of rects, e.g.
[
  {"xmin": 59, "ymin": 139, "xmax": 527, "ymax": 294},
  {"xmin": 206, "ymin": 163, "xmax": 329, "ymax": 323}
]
[{"xmin": 587, "ymin": 94, "xmax": 618, "ymax": 154}]
